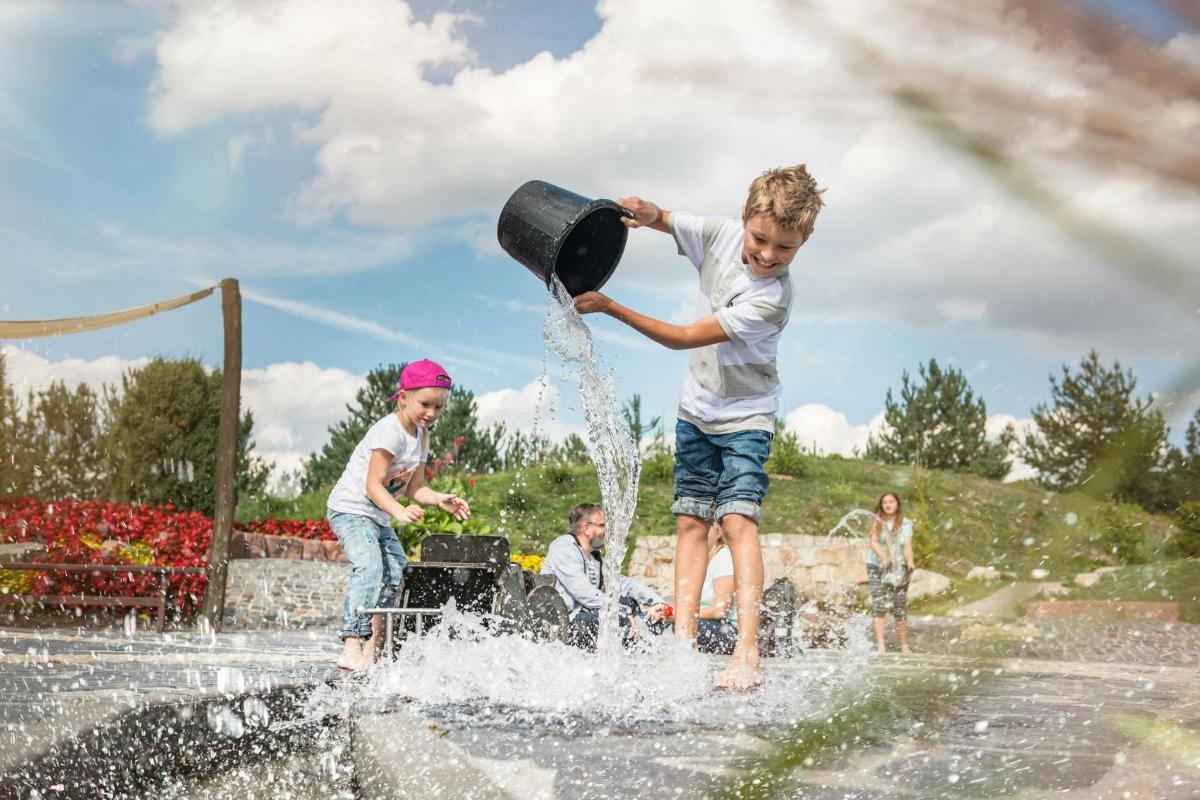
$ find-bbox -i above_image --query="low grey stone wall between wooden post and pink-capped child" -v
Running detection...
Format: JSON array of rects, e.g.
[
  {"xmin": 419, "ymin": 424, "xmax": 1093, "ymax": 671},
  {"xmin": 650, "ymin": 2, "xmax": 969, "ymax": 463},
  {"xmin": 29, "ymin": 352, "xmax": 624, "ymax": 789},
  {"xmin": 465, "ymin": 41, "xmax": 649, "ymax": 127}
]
[{"xmin": 224, "ymin": 558, "xmax": 350, "ymax": 636}]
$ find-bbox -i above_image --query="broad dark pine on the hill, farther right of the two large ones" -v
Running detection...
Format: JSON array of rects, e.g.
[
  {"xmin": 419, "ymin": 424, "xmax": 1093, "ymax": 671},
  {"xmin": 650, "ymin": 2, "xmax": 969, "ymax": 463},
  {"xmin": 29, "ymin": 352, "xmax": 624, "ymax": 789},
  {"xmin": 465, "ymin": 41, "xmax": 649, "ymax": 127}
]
[{"xmin": 1021, "ymin": 350, "xmax": 1170, "ymax": 507}]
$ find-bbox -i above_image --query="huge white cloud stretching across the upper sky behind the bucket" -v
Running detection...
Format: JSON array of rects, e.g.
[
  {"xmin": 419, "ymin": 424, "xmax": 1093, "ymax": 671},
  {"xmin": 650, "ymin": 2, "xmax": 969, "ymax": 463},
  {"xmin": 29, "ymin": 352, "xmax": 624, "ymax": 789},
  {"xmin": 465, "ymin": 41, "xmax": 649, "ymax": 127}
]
[{"xmin": 138, "ymin": 0, "xmax": 1200, "ymax": 355}]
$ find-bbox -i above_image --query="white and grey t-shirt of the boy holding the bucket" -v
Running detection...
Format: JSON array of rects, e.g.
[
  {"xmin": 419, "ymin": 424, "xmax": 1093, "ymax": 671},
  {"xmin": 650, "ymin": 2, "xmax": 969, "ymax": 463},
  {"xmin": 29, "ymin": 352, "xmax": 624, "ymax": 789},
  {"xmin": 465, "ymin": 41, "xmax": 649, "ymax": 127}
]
[{"xmin": 667, "ymin": 211, "xmax": 792, "ymax": 435}]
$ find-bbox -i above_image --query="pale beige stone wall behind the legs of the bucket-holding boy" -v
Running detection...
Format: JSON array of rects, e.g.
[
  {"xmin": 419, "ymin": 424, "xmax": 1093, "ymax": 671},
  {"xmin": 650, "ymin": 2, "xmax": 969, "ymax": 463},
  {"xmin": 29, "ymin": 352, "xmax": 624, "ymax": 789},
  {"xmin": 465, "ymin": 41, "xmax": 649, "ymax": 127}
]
[{"xmin": 629, "ymin": 534, "xmax": 866, "ymax": 597}]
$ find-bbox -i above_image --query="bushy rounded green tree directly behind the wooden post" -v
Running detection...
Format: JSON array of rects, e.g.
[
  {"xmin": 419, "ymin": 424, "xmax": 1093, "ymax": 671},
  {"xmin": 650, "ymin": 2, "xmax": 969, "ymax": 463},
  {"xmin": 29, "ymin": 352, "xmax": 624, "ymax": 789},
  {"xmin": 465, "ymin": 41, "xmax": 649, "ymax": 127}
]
[{"xmin": 103, "ymin": 357, "xmax": 270, "ymax": 516}]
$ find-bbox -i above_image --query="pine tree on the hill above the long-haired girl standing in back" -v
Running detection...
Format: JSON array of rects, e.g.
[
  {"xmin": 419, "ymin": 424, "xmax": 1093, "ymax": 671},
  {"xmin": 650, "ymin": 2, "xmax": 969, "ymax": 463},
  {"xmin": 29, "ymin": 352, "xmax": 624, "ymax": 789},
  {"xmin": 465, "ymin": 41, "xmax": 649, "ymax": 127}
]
[{"xmin": 866, "ymin": 359, "xmax": 1015, "ymax": 479}]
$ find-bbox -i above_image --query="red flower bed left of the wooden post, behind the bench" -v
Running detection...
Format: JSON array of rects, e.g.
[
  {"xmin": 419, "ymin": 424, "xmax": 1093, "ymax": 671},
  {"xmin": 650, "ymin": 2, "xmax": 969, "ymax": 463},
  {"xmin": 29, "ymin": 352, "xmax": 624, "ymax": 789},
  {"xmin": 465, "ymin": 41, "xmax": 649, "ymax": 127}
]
[{"xmin": 0, "ymin": 497, "xmax": 212, "ymax": 613}]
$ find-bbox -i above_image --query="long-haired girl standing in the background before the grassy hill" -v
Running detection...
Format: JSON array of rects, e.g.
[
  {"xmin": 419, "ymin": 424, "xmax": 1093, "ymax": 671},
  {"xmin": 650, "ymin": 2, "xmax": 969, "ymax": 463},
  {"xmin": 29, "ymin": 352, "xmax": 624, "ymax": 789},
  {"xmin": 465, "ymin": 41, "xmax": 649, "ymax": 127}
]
[{"xmin": 866, "ymin": 492, "xmax": 917, "ymax": 652}]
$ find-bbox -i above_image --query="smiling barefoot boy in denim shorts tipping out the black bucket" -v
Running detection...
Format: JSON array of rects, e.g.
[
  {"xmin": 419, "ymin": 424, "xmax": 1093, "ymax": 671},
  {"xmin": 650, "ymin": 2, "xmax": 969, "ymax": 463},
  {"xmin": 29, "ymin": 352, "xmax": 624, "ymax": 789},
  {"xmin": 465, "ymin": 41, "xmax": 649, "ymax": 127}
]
[{"xmin": 575, "ymin": 164, "xmax": 822, "ymax": 690}]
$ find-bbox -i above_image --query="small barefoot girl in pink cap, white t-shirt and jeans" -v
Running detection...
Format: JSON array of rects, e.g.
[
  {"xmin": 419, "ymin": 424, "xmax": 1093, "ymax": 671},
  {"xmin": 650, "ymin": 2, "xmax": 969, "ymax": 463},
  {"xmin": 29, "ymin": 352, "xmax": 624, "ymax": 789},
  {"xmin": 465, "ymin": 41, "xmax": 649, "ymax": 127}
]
[{"xmin": 328, "ymin": 360, "xmax": 470, "ymax": 670}]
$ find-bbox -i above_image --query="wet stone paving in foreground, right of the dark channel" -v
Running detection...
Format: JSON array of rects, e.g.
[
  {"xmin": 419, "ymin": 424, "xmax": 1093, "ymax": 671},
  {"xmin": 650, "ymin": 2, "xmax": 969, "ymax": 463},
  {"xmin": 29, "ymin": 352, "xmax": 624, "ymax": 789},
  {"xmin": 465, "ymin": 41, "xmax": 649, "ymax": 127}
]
[{"xmin": 352, "ymin": 652, "xmax": 1200, "ymax": 800}]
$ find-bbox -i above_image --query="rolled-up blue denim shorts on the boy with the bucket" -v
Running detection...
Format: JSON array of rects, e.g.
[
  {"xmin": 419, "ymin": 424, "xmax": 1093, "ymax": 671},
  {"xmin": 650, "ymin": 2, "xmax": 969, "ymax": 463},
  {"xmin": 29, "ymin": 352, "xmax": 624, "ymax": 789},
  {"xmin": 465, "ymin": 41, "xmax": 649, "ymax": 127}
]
[{"xmin": 671, "ymin": 420, "xmax": 773, "ymax": 523}]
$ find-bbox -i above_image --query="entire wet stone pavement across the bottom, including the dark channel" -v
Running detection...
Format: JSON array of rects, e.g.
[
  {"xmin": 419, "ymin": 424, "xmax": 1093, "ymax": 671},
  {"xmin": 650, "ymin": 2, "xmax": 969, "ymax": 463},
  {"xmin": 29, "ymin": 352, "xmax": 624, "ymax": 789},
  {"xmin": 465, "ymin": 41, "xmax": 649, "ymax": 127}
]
[{"xmin": 0, "ymin": 619, "xmax": 1200, "ymax": 800}]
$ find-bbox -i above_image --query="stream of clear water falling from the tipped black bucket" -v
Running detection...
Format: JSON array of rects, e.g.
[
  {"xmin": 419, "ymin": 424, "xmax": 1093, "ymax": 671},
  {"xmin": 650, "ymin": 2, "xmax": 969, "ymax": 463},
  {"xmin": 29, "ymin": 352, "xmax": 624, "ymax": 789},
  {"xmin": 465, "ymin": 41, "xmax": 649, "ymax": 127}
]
[{"xmin": 542, "ymin": 277, "xmax": 642, "ymax": 666}]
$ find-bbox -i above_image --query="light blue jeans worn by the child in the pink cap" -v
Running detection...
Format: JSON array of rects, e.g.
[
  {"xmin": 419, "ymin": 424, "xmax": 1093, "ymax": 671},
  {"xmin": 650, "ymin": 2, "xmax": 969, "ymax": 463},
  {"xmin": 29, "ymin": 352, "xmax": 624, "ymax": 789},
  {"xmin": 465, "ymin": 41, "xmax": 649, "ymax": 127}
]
[{"xmin": 329, "ymin": 511, "xmax": 408, "ymax": 639}]
